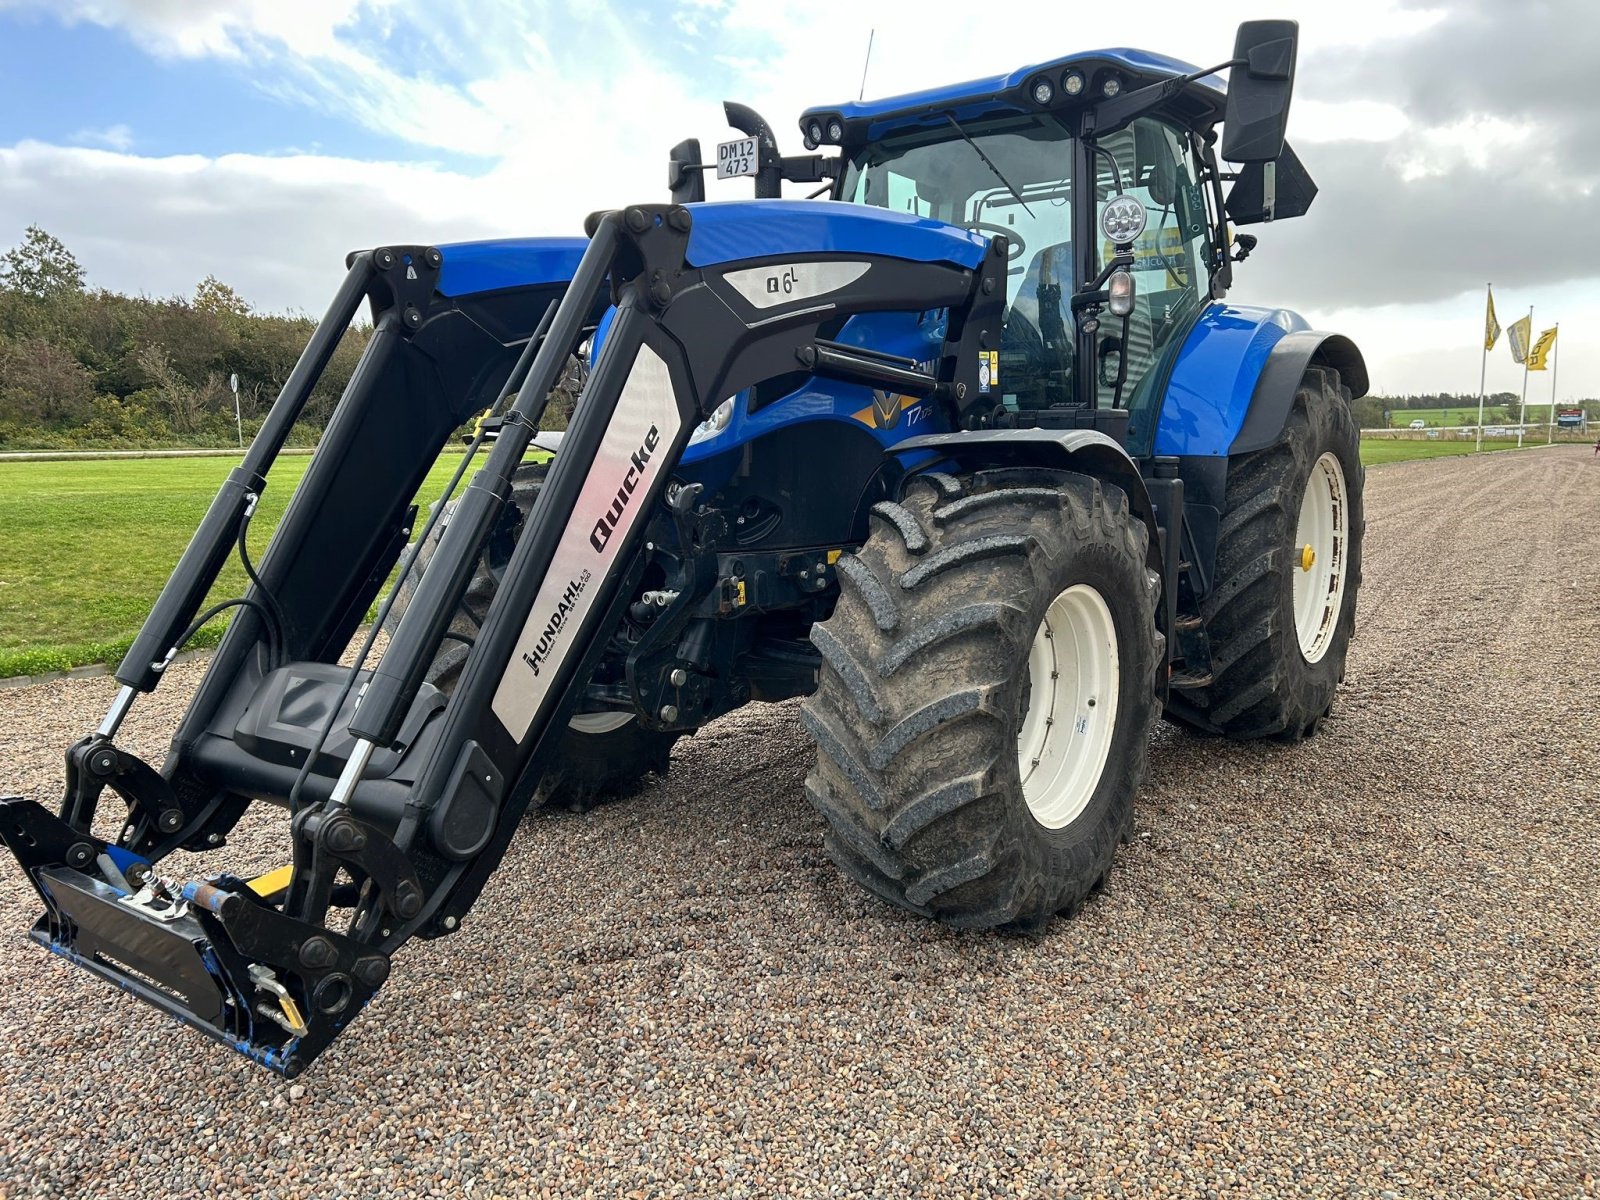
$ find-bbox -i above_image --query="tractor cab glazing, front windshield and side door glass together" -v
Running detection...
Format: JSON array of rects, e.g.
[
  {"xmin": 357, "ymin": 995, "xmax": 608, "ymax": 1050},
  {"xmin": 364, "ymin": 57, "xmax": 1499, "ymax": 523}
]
[{"xmin": 838, "ymin": 112, "xmax": 1211, "ymax": 418}]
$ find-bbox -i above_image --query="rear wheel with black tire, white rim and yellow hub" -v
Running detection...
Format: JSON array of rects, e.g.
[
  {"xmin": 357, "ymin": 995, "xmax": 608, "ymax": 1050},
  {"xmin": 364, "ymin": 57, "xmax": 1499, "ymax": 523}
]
[{"xmin": 1184, "ymin": 366, "xmax": 1366, "ymax": 741}]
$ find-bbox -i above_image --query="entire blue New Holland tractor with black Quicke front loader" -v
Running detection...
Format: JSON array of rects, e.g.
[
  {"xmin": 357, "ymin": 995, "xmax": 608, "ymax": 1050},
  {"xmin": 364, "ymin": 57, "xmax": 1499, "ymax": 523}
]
[{"xmin": 0, "ymin": 21, "xmax": 1366, "ymax": 1075}]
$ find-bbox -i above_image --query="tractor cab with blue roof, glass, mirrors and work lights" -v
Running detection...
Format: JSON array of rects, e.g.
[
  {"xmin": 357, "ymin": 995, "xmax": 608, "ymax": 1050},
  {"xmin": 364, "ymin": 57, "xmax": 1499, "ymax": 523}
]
[{"xmin": 672, "ymin": 21, "xmax": 1315, "ymax": 448}]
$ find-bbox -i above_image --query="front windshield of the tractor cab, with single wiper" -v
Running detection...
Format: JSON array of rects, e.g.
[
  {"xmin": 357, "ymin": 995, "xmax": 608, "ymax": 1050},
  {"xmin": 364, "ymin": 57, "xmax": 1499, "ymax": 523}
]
[{"xmin": 843, "ymin": 117, "xmax": 1075, "ymax": 408}]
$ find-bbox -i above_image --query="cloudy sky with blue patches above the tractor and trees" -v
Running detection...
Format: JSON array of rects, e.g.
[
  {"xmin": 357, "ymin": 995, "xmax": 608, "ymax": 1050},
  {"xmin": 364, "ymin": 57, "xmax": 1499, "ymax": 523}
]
[{"xmin": 0, "ymin": 0, "xmax": 1600, "ymax": 400}]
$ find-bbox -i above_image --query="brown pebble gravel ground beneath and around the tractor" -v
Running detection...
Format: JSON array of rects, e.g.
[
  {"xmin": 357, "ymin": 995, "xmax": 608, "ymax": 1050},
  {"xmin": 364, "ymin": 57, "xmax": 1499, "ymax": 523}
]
[{"xmin": 0, "ymin": 448, "xmax": 1600, "ymax": 1197}]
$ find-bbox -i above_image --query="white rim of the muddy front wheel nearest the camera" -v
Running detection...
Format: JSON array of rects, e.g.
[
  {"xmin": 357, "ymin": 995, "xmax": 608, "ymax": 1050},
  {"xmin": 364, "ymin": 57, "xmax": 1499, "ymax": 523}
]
[{"xmin": 1016, "ymin": 584, "xmax": 1118, "ymax": 829}]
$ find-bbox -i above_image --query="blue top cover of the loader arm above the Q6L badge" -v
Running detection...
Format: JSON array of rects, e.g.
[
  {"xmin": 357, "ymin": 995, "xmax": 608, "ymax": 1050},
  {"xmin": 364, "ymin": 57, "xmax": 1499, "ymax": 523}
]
[{"xmin": 686, "ymin": 200, "xmax": 989, "ymax": 269}]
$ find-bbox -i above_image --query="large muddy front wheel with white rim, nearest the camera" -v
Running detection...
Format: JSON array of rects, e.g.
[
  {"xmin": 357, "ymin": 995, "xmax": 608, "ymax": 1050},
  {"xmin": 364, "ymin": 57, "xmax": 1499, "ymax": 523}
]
[{"xmin": 802, "ymin": 470, "xmax": 1163, "ymax": 928}]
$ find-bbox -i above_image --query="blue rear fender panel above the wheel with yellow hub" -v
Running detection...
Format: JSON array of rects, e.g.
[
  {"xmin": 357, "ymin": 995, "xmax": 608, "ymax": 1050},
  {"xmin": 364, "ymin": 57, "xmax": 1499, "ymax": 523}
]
[{"xmin": 1155, "ymin": 301, "xmax": 1310, "ymax": 456}]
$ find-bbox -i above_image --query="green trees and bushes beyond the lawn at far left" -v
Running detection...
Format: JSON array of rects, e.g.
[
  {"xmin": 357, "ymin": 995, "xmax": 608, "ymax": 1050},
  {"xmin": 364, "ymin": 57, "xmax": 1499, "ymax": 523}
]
[{"xmin": 0, "ymin": 226, "xmax": 371, "ymax": 450}]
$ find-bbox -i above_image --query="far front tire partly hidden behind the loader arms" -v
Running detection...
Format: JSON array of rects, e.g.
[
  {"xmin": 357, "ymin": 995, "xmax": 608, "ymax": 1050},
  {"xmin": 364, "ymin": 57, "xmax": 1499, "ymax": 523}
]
[{"xmin": 389, "ymin": 462, "xmax": 682, "ymax": 811}]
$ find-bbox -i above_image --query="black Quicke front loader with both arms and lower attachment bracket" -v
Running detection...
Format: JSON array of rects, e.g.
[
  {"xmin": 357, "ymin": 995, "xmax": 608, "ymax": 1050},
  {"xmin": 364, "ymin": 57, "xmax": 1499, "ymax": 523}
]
[{"xmin": 0, "ymin": 202, "xmax": 1006, "ymax": 1075}]
